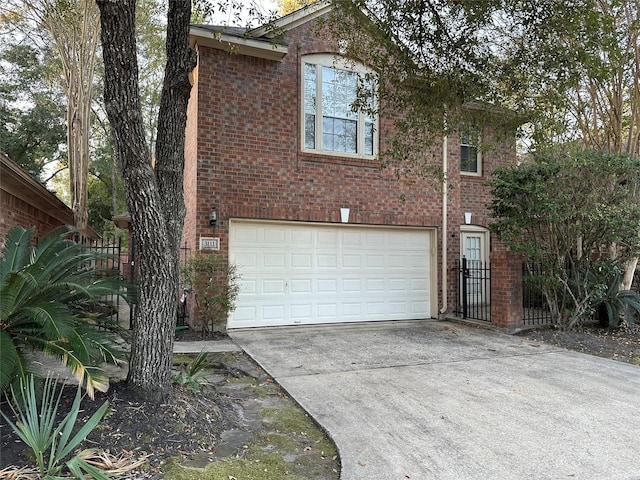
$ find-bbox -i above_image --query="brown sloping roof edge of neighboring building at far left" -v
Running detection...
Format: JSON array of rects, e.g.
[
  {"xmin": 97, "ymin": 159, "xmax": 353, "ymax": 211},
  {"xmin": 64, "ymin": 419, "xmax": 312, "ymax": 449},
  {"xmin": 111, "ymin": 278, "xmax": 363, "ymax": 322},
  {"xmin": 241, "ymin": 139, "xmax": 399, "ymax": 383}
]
[{"xmin": 0, "ymin": 152, "xmax": 100, "ymax": 238}]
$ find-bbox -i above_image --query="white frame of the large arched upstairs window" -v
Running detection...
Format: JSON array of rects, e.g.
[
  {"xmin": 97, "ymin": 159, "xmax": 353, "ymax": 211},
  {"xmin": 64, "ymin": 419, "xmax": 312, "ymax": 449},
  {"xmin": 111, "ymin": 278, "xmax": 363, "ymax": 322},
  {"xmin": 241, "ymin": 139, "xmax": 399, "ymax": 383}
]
[{"xmin": 300, "ymin": 54, "xmax": 378, "ymax": 159}]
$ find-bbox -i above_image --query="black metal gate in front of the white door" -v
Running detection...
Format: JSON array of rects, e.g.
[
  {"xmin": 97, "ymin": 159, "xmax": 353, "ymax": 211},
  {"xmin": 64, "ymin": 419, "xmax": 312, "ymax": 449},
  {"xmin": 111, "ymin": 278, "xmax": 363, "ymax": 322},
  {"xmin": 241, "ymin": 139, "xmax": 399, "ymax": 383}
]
[{"xmin": 455, "ymin": 257, "xmax": 491, "ymax": 322}]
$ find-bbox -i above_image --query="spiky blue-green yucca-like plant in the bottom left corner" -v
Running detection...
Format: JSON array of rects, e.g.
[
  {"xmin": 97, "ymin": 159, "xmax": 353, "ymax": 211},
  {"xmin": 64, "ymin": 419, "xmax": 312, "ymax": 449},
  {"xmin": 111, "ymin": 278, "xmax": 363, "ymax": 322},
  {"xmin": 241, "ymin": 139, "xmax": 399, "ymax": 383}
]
[{"xmin": 0, "ymin": 376, "xmax": 109, "ymax": 480}]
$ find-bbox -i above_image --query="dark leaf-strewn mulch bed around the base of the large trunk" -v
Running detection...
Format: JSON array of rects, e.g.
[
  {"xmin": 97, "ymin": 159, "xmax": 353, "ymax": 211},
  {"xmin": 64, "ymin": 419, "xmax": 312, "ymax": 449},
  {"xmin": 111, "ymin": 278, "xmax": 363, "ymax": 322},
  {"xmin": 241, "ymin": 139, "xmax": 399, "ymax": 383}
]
[{"xmin": 0, "ymin": 342, "xmax": 251, "ymax": 478}]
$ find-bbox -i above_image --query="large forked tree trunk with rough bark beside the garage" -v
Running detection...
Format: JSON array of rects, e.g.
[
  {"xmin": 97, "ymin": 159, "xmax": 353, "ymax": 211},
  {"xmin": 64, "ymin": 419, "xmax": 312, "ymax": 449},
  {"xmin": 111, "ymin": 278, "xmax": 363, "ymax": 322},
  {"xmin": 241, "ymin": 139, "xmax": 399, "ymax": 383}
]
[{"xmin": 98, "ymin": 0, "xmax": 195, "ymax": 402}]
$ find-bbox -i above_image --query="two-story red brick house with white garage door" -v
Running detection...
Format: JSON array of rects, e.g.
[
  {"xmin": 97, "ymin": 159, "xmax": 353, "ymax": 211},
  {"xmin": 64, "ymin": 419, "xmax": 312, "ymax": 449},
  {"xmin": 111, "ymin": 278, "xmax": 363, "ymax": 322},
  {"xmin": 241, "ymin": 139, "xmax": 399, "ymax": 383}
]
[{"xmin": 183, "ymin": 2, "xmax": 521, "ymax": 328}]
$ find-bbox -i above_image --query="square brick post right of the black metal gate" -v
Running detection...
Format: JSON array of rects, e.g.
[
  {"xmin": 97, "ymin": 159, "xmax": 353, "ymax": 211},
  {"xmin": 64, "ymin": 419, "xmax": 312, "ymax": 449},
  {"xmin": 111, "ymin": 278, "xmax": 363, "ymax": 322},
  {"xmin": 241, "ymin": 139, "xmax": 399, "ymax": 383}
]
[{"xmin": 490, "ymin": 250, "xmax": 524, "ymax": 332}]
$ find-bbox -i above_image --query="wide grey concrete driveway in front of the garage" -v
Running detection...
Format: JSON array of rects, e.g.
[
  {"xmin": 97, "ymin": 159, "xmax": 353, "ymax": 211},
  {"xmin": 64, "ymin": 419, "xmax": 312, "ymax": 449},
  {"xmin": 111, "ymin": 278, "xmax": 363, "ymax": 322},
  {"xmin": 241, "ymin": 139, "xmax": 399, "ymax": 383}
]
[{"xmin": 231, "ymin": 320, "xmax": 640, "ymax": 480}]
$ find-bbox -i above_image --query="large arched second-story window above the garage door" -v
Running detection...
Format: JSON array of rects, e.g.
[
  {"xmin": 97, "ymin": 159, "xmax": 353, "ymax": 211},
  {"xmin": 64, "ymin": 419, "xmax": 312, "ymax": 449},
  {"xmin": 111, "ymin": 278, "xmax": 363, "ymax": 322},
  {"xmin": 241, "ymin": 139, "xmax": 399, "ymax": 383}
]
[{"xmin": 303, "ymin": 55, "xmax": 377, "ymax": 157}]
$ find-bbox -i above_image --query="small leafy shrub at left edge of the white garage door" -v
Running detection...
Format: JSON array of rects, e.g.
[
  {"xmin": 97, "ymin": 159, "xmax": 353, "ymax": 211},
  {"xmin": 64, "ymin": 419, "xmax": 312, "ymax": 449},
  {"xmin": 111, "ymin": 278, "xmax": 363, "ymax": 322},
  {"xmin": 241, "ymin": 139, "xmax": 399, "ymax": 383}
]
[{"xmin": 181, "ymin": 253, "xmax": 239, "ymax": 332}]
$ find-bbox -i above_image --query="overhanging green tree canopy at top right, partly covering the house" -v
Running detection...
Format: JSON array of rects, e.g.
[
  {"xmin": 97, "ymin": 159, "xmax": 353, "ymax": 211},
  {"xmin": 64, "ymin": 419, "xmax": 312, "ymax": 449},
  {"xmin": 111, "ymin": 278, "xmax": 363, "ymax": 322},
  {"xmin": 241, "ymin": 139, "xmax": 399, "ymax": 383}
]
[{"xmin": 330, "ymin": 0, "xmax": 640, "ymax": 168}]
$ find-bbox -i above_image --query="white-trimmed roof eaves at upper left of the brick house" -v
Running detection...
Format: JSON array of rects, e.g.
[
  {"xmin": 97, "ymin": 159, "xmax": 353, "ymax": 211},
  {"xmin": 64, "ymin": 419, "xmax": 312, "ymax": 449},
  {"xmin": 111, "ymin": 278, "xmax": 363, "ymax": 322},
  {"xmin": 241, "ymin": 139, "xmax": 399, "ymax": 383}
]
[{"xmin": 189, "ymin": 0, "xmax": 331, "ymax": 61}]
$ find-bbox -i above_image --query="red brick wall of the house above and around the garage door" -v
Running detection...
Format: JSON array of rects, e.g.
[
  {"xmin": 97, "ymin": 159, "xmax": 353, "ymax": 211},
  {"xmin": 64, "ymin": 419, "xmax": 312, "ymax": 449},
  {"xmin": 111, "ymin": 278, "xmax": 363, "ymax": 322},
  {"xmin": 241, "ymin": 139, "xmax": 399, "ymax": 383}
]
[{"xmin": 184, "ymin": 15, "xmax": 515, "ymax": 316}]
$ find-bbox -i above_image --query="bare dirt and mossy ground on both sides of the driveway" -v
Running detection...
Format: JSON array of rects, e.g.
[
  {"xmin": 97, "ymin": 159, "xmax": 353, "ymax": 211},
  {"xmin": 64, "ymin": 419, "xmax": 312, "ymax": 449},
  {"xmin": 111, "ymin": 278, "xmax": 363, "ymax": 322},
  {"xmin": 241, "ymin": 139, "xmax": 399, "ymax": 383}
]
[{"xmin": 0, "ymin": 325, "xmax": 640, "ymax": 480}]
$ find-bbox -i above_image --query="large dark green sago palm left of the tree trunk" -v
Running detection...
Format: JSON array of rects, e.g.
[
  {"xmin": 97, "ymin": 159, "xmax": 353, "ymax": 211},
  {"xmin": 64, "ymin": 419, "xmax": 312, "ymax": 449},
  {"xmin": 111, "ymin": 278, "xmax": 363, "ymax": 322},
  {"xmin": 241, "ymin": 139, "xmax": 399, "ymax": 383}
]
[{"xmin": 0, "ymin": 227, "xmax": 124, "ymax": 397}]
